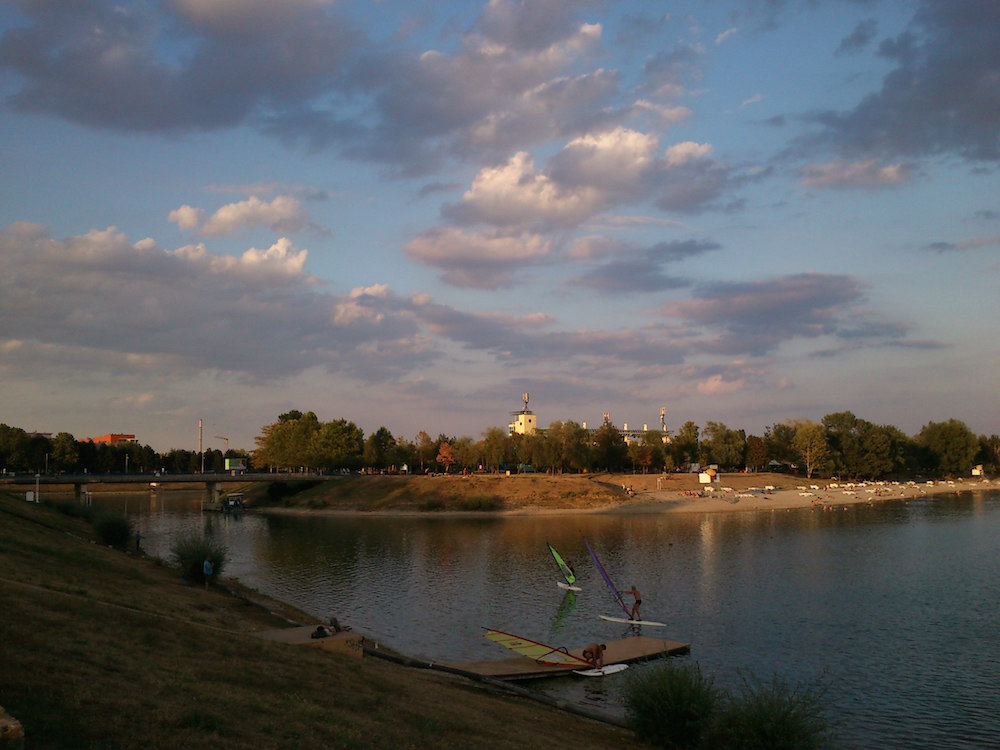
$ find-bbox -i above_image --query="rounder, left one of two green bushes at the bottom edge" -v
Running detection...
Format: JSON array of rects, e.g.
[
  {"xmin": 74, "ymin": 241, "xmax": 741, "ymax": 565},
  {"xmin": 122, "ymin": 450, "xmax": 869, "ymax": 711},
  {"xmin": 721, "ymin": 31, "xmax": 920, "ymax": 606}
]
[{"xmin": 625, "ymin": 662, "xmax": 720, "ymax": 748}]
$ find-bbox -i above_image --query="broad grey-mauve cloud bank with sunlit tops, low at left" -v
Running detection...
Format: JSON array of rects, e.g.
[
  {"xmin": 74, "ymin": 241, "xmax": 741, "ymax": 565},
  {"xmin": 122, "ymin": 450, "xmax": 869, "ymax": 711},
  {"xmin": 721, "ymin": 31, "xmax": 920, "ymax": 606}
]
[{"xmin": 0, "ymin": 223, "xmax": 422, "ymax": 381}]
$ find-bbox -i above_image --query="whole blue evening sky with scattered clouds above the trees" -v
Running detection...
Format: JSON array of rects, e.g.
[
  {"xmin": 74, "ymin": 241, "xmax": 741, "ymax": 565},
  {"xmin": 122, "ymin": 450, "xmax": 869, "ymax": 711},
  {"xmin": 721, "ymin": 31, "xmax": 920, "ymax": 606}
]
[{"xmin": 0, "ymin": 0, "xmax": 1000, "ymax": 451}]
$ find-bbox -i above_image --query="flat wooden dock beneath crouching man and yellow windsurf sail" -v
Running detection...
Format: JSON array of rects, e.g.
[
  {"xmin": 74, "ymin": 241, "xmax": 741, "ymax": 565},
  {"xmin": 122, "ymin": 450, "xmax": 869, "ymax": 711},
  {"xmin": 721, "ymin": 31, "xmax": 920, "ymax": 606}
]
[{"xmin": 447, "ymin": 635, "xmax": 691, "ymax": 681}]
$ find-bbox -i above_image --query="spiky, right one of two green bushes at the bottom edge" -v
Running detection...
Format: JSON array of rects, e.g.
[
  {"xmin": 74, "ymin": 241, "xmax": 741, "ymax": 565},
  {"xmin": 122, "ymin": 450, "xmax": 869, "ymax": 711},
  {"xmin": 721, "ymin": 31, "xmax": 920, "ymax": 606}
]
[{"xmin": 712, "ymin": 676, "xmax": 831, "ymax": 750}]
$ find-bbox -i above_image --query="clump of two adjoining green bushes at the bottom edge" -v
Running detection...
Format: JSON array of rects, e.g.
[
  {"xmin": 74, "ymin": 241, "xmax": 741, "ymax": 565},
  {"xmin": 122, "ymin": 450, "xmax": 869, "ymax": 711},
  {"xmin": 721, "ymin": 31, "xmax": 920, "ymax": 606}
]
[{"xmin": 625, "ymin": 662, "xmax": 832, "ymax": 750}]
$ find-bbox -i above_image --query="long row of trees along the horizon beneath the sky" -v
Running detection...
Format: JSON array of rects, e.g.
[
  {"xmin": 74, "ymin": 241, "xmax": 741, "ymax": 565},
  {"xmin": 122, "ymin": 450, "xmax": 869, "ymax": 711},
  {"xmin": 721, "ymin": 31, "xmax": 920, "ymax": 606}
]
[{"xmin": 0, "ymin": 410, "xmax": 1000, "ymax": 479}]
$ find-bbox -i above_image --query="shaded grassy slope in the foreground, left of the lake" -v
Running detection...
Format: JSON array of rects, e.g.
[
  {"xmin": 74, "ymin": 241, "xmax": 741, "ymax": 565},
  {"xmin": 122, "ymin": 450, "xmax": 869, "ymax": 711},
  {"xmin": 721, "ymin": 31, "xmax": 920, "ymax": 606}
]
[{"xmin": 0, "ymin": 495, "xmax": 635, "ymax": 750}]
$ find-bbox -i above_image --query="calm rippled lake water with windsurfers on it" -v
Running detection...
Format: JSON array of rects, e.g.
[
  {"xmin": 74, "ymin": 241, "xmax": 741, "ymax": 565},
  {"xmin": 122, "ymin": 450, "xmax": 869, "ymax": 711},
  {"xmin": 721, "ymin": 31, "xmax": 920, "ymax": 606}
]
[{"xmin": 115, "ymin": 492, "xmax": 1000, "ymax": 748}]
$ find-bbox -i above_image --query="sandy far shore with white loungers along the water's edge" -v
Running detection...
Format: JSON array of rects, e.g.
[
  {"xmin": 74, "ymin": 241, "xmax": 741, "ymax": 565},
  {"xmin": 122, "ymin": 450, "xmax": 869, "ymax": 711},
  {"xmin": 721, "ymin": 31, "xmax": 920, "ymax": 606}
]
[{"xmin": 260, "ymin": 478, "xmax": 1000, "ymax": 518}]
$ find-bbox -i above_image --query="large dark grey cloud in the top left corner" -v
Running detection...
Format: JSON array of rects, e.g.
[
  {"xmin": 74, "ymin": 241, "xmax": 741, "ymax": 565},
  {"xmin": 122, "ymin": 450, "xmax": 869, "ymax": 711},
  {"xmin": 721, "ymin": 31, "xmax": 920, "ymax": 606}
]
[{"xmin": 0, "ymin": 0, "xmax": 364, "ymax": 133}]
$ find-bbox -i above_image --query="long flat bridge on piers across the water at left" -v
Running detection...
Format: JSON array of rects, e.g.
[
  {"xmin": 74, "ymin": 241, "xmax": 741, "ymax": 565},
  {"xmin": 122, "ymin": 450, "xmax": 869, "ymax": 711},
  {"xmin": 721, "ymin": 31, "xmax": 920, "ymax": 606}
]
[{"xmin": 0, "ymin": 472, "xmax": 341, "ymax": 502}]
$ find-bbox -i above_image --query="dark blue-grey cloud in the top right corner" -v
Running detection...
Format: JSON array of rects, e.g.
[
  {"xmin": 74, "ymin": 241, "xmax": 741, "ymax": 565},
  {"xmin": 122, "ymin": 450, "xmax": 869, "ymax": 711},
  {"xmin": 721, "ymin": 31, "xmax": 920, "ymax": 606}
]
[{"xmin": 803, "ymin": 0, "xmax": 1000, "ymax": 162}]
